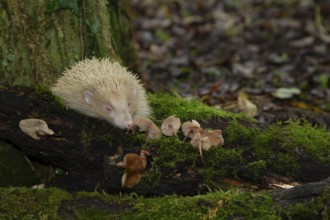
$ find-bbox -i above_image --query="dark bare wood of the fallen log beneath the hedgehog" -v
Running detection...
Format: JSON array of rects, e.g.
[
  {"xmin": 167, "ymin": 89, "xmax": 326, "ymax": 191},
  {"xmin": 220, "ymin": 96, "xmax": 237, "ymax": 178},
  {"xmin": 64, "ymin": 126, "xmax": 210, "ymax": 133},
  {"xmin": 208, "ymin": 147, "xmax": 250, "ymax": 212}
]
[{"xmin": 0, "ymin": 87, "xmax": 330, "ymax": 195}]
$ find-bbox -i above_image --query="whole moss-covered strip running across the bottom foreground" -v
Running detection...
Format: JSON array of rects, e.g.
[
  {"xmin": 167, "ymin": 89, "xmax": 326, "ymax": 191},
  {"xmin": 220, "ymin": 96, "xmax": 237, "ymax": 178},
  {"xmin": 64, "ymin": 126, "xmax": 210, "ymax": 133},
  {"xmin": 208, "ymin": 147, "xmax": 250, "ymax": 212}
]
[{"xmin": 0, "ymin": 188, "xmax": 330, "ymax": 220}]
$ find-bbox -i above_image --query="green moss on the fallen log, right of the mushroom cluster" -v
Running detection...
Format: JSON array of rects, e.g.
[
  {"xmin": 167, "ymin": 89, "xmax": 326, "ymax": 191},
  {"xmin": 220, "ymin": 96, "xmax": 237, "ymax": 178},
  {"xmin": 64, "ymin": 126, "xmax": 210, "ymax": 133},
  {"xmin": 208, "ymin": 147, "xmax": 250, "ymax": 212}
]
[{"xmin": 224, "ymin": 120, "xmax": 330, "ymax": 180}]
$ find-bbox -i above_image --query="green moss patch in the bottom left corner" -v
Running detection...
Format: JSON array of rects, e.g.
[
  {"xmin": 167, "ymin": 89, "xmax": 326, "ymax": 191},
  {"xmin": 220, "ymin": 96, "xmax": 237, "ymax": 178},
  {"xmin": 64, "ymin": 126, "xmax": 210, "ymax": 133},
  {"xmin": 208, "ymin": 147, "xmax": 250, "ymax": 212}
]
[{"xmin": 0, "ymin": 188, "xmax": 71, "ymax": 220}]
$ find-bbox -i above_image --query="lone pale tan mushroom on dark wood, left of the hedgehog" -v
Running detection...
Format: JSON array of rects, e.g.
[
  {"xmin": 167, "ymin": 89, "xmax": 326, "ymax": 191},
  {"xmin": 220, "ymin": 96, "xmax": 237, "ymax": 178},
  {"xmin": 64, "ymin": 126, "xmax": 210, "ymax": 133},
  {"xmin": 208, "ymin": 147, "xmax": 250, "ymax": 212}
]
[{"xmin": 19, "ymin": 118, "xmax": 55, "ymax": 140}]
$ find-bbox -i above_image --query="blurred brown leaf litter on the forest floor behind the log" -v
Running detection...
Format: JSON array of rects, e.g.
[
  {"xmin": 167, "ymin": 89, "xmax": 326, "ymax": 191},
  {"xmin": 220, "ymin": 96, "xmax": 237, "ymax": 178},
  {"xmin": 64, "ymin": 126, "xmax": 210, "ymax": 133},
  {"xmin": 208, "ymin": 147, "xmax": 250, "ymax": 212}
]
[{"xmin": 129, "ymin": 0, "xmax": 330, "ymax": 129}]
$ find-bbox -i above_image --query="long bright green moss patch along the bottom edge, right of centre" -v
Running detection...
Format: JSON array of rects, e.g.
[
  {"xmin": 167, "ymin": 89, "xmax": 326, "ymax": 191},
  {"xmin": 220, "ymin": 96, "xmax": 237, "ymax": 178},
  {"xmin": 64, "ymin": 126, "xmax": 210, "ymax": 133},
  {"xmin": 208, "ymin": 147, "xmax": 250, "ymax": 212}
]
[{"xmin": 122, "ymin": 190, "xmax": 280, "ymax": 219}]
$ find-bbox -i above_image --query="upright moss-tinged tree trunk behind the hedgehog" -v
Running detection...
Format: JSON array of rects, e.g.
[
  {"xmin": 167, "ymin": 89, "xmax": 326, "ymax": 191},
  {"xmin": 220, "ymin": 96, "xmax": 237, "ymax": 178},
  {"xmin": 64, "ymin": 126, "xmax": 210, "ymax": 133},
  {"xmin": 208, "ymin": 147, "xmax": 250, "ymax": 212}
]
[{"xmin": 0, "ymin": 0, "xmax": 134, "ymax": 85}]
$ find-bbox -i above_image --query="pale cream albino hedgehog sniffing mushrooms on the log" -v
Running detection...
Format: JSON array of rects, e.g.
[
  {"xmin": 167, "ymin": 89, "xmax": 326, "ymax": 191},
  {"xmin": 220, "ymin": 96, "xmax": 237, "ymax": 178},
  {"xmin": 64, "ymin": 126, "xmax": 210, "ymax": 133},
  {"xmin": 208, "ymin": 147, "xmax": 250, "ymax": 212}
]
[{"xmin": 51, "ymin": 58, "xmax": 150, "ymax": 129}]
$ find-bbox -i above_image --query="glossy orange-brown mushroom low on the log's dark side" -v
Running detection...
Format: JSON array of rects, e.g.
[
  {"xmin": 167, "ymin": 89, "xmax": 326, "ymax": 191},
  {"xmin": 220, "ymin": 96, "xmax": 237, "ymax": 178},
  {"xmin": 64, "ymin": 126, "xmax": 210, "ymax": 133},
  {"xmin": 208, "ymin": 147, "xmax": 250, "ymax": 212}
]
[{"xmin": 117, "ymin": 150, "xmax": 150, "ymax": 188}]
